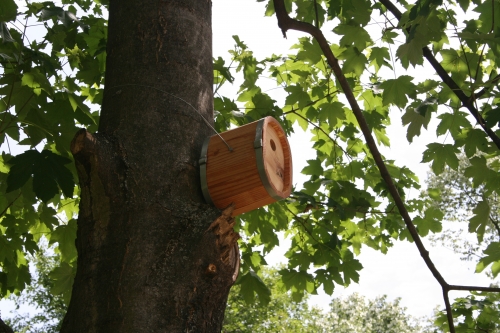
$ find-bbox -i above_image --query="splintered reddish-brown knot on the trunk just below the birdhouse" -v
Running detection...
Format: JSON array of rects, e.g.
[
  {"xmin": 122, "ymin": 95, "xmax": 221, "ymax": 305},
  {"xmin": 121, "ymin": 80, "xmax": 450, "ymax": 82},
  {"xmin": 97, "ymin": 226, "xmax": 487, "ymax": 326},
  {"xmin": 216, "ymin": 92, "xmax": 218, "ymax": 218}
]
[{"xmin": 207, "ymin": 204, "xmax": 240, "ymax": 282}]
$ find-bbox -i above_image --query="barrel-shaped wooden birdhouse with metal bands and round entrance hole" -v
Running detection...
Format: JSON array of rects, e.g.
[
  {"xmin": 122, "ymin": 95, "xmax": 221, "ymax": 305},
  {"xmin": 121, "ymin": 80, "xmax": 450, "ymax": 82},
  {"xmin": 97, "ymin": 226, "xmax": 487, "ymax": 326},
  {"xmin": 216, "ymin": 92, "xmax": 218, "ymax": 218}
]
[{"xmin": 200, "ymin": 117, "xmax": 292, "ymax": 216}]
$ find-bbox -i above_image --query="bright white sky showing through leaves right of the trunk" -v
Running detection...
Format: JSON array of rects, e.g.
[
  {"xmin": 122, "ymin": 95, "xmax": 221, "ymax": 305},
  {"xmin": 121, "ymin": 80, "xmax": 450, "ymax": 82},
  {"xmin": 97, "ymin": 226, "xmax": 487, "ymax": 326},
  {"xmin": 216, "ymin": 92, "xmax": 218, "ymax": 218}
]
[{"xmin": 212, "ymin": 0, "xmax": 500, "ymax": 317}]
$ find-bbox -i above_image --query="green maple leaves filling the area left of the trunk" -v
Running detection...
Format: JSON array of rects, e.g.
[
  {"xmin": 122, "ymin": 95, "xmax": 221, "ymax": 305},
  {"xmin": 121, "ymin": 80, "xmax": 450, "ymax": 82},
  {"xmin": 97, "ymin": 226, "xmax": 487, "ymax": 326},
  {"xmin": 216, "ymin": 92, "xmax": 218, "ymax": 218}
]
[{"xmin": 0, "ymin": 0, "xmax": 107, "ymax": 303}]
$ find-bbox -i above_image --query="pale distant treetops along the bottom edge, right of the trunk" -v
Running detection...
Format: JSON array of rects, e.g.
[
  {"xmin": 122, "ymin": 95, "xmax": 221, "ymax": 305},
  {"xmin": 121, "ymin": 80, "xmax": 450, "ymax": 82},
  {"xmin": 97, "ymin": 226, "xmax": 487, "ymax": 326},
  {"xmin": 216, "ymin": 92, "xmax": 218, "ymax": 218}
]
[{"xmin": 223, "ymin": 269, "xmax": 432, "ymax": 333}]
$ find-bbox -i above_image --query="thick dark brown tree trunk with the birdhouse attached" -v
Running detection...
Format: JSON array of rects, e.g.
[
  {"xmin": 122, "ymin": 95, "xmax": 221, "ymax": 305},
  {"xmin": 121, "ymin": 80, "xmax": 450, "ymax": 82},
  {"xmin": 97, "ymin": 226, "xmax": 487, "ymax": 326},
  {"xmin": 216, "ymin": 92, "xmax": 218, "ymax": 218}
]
[{"xmin": 61, "ymin": 0, "xmax": 239, "ymax": 333}]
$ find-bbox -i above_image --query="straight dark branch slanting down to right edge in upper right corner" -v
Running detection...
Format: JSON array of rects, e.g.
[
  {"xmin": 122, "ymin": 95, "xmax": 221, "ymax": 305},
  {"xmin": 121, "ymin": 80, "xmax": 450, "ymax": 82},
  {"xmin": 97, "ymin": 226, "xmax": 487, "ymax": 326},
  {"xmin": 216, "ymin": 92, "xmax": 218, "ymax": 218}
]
[{"xmin": 379, "ymin": 0, "xmax": 500, "ymax": 149}]
